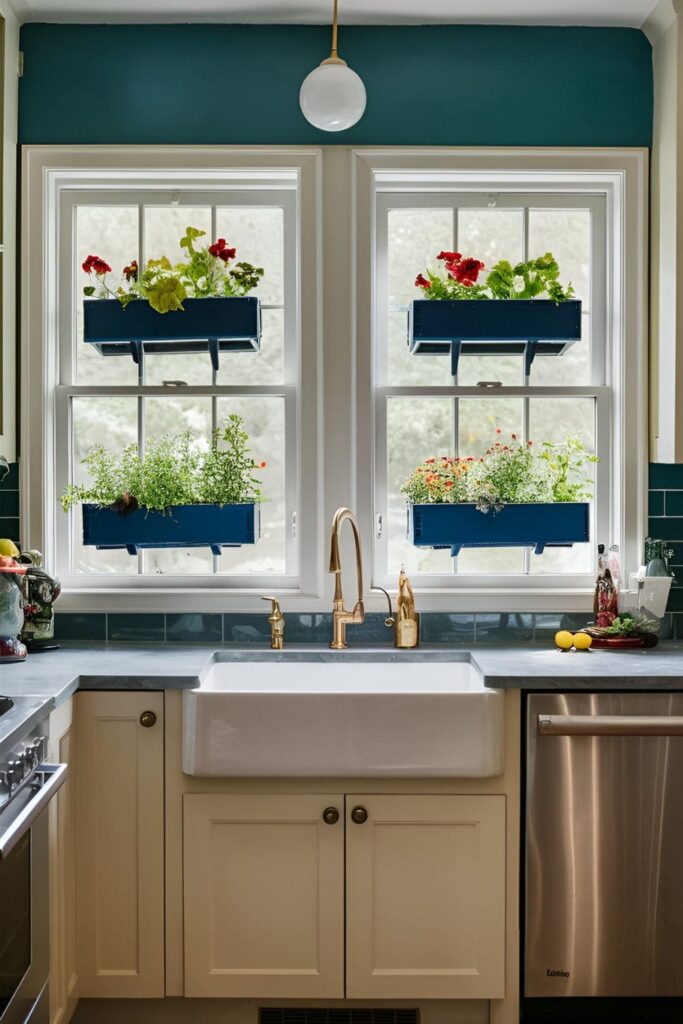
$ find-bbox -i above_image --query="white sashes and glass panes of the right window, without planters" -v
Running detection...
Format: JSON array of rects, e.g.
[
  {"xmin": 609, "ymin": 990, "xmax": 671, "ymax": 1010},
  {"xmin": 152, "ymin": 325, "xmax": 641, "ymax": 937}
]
[{"xmin": 373, "ymin": 191, "xmax": 609, "ymax": 588}]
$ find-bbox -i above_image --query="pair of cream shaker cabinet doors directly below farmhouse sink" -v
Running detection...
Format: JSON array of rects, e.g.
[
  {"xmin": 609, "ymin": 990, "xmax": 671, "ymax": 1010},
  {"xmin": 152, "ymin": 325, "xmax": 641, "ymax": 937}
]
[{"xmin": 183, "ymin": 795, "xmax": 505, "ymax": 999}]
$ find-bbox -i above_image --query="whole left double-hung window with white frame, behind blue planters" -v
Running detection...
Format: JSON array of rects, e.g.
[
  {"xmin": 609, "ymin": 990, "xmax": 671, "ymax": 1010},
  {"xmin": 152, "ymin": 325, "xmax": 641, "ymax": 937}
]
[{"xmin": 25, "ymin": 151, "xmax": 317, "ymax": 593}]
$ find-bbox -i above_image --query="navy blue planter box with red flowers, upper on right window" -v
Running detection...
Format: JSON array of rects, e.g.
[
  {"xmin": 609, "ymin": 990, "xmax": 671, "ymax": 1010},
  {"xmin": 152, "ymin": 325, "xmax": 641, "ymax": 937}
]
[{"xmin": 408, "ymin": 299, "xmax": 581, "ymax": 377}]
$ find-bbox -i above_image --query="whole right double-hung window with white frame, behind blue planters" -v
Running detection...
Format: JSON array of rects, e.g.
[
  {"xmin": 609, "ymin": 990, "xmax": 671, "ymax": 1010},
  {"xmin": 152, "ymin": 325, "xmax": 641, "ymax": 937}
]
[{"xmin": 357, "ymin": 154, "xmax": 644, "ymax": 607}]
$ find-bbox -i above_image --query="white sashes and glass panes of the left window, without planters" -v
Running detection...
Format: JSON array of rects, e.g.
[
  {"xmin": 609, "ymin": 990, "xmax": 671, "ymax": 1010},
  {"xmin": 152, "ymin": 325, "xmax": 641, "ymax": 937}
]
[{"xmin": 55, "ymin": 188, "xmax": 299, "ymax": 588}]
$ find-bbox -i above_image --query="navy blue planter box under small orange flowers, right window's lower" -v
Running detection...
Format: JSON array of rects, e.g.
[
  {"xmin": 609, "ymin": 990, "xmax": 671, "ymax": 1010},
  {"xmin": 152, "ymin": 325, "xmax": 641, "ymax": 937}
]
[{"xmin": 408, "ymin": 502, "xmax": 590, "ymax": 558}]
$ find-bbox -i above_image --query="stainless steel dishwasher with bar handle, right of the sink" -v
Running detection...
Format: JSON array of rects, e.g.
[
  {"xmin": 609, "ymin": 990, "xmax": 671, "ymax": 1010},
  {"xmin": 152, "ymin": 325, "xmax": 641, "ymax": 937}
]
[{"xmin": 523, "ymin": 691, "xmax": 683, "ymax": 1022}]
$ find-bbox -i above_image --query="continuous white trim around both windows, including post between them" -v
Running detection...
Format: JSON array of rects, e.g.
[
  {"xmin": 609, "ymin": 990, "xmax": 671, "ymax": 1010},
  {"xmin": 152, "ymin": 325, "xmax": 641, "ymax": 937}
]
[{"xmin": 20, "ymin": 146, "xmax": 647, "ymax": 612}]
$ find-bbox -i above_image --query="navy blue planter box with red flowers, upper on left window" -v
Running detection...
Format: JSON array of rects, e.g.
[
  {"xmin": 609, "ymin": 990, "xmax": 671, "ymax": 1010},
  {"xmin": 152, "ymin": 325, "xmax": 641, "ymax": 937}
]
[{"xmin": 83, "ymin": 295, "xmax": 261, "ymax": 370}]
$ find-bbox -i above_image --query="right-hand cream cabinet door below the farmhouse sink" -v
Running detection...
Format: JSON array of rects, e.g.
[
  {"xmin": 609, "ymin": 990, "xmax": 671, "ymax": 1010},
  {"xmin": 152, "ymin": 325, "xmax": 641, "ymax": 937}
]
[{"xmin": 346, "ymin": 796, "xmax": 505, "ymax": 998}]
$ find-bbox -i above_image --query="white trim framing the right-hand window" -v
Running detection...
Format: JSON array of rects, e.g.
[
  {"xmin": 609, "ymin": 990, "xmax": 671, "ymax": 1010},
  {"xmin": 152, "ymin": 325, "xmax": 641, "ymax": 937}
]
[{"xmin": 352, "ymin": 150, "xmax": 647, "ymax": 611}]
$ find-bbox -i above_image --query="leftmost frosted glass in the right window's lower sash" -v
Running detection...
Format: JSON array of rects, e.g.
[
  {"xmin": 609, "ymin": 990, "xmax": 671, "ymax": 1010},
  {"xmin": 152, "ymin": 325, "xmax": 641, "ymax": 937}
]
[{"xmin": 386, "ymin": 398, "xmax": 453, "ymax": 574}]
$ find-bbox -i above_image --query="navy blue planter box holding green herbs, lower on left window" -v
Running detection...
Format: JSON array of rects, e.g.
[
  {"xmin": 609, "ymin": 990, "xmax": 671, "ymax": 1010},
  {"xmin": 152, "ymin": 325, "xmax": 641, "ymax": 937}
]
[{"xmin": 83, "ymin": 502, "xmax": 260, "ymax": 555}]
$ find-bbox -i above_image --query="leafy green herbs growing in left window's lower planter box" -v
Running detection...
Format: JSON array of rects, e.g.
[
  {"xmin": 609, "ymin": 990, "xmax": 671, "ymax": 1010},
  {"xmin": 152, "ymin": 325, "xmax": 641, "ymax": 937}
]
[{"xmin": 60, "ymin": 415, "xmax": 266, "ymax": 512}]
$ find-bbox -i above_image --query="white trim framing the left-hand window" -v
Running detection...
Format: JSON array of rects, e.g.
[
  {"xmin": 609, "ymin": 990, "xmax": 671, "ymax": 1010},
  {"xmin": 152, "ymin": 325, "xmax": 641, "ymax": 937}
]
[{"xmin": 20, "ymin": 146, "xmax": 325, "ymax": 611}]
